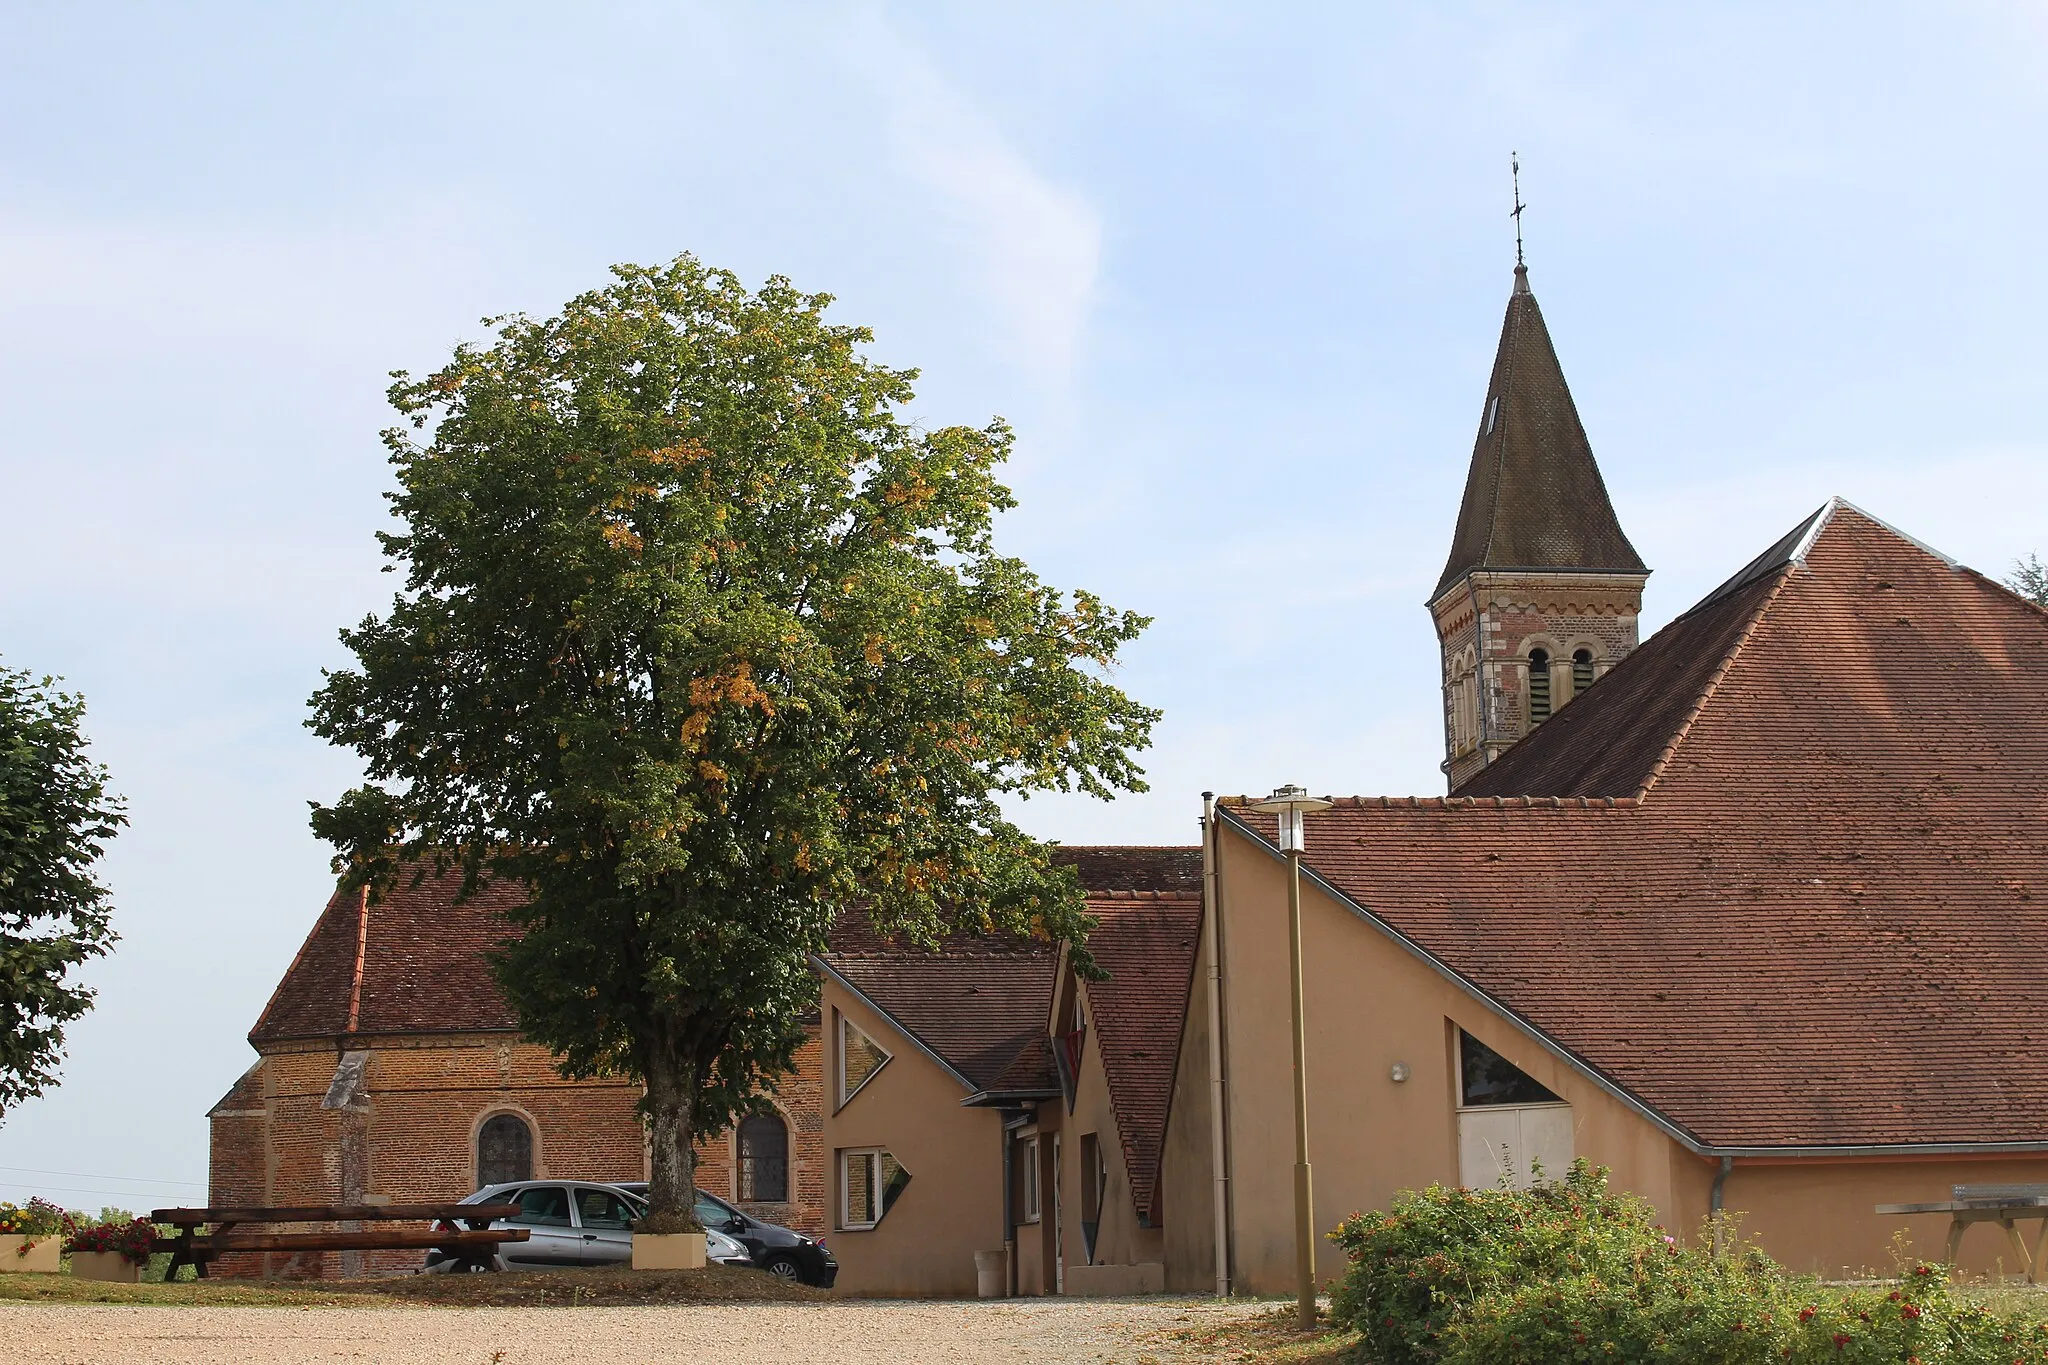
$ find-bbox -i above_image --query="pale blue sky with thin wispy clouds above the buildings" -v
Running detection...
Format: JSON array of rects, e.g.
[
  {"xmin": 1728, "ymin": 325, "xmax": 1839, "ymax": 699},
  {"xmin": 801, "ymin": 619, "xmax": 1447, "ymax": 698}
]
[{"xmin": 0, "ymin": 0, "xmax": 2048, "ymax": 1209}]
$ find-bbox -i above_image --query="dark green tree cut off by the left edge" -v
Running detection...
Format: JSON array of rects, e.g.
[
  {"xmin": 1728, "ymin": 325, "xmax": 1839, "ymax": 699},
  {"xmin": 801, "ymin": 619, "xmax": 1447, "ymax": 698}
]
[{"xmin": 0, "ymin": 667, "xmax": 127, "ymax": 1113}]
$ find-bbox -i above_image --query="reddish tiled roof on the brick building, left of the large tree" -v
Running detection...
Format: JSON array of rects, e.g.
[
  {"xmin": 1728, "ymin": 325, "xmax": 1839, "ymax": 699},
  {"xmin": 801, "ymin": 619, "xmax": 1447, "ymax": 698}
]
[{"xmin": 250, "ymin": 872, "xmax": 522, "ymax": 1046}]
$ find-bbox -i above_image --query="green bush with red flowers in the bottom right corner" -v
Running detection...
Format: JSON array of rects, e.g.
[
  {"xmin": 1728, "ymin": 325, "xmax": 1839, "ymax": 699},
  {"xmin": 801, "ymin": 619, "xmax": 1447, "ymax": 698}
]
[{"xmin": 1333, "ymin": 1160, "xmax": 2048, "ymax": 1365}]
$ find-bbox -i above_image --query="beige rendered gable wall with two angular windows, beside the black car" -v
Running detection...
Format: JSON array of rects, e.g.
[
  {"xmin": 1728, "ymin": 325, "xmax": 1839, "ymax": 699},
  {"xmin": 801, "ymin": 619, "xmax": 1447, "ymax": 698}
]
[{"xmin": 821, "ymin": 980, "xmax": 1004, "ymax": 1297}]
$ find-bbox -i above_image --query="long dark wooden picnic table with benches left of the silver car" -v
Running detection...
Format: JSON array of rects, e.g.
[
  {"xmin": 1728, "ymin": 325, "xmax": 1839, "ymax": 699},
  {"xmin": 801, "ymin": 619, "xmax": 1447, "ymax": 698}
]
[{"xmin": 150, "ymin": 1203, "xmax": 532, "ymax": 1281}]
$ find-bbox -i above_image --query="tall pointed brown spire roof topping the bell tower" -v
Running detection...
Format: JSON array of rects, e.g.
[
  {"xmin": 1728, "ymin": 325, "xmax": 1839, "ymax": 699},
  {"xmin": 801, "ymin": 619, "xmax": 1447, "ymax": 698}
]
[{"xmin": 1430, "ymin": 266, "xmax": 1649, "ymax": 600}]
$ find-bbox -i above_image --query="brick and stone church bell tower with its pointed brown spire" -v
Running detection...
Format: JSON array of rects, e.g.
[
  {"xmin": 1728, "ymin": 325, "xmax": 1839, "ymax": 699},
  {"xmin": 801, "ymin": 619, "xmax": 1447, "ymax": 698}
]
[{"xmin": 1430, "ymin": 264, "xmax": 1651, "ymax": 792}]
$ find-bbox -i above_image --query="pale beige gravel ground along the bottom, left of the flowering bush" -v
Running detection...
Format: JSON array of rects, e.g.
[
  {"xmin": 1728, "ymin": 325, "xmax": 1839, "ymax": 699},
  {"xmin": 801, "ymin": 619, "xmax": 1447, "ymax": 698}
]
[{"xmin": 0, "ymin": 1300, "xmax": 1260, "ymax": 1365}]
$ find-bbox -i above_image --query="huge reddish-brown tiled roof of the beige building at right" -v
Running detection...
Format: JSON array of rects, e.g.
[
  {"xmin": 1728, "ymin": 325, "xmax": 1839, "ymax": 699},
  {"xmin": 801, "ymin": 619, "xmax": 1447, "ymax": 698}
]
[{"xmin": 1233, "ymin": 503, "xmax": 2048, "ymax": 1148}]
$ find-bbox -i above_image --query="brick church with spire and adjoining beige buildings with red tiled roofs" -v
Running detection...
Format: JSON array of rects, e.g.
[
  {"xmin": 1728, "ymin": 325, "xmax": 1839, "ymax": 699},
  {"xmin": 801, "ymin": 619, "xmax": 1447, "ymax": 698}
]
[{"xmin": 211, "ymin": 255, "xmax": 2048, "ymax": 1295}]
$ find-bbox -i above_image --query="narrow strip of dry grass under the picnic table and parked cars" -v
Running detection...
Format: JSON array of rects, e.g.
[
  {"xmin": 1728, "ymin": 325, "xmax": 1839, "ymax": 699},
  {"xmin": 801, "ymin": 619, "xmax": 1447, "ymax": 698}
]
[{"xmin": 0, "ymin": 1265, "xmax": 834, "ymax": 1308}]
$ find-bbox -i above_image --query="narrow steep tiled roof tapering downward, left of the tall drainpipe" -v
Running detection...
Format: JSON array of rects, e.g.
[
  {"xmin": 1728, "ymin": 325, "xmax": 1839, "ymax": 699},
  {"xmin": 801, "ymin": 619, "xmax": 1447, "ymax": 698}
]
[{"xmin": 1087, "ymin": 896, "xmax": 1202, "ymax": 1226}]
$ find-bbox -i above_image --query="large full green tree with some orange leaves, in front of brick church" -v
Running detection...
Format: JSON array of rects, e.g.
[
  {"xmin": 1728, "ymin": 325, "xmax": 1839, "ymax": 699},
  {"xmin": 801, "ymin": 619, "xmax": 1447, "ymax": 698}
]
[{"xmin": 309, "ymin": 256, "xmax": 1157, "ymax": 1230}]
